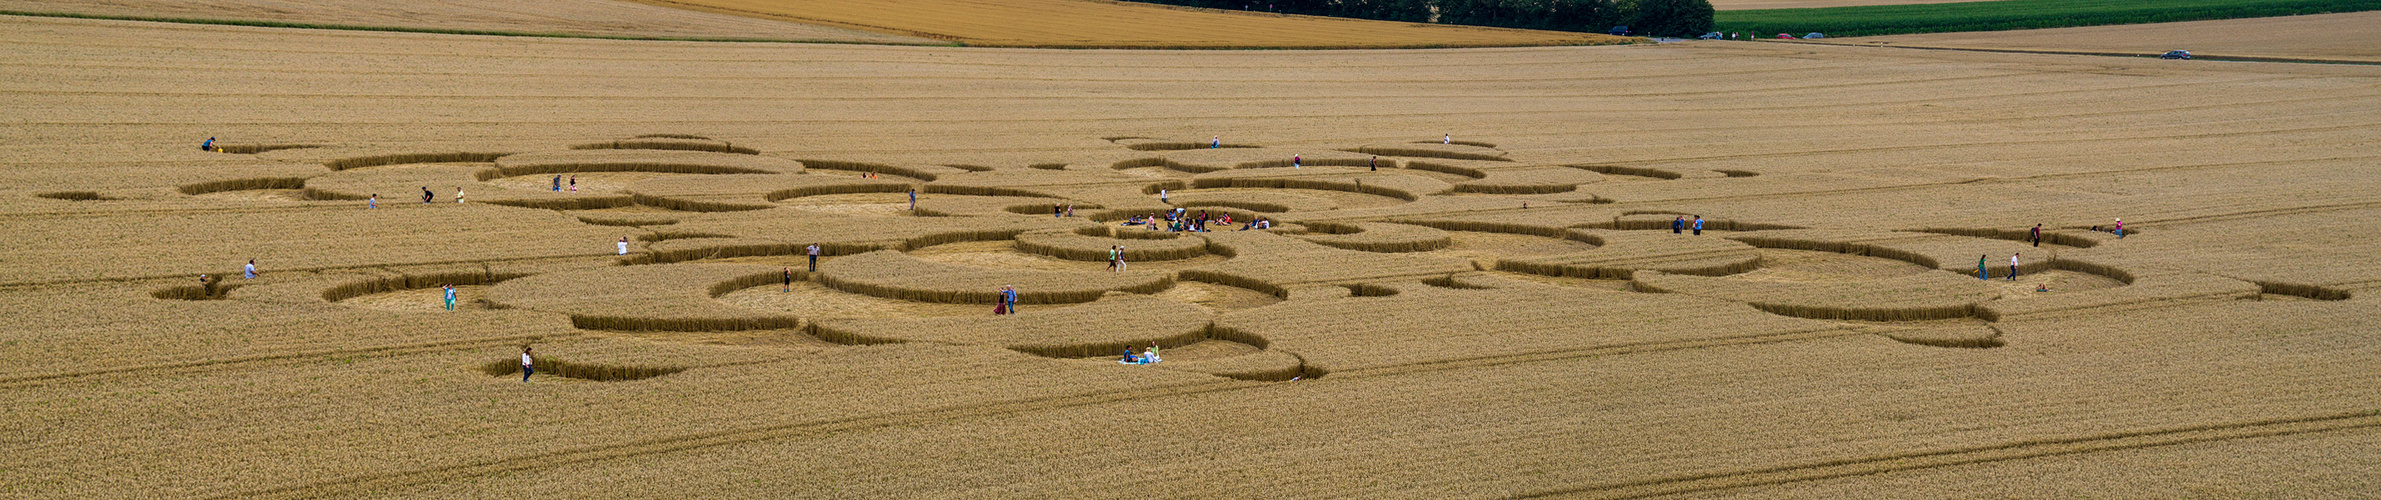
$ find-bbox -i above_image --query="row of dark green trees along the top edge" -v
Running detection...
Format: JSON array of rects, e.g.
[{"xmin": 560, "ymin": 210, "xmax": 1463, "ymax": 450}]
[{"xmin": 1136, "ymin": 0, "xmax": 1712, "ymax": 36}]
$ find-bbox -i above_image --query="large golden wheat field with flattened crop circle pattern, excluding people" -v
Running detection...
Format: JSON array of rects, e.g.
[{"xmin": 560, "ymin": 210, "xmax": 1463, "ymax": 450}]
[{"xmin": 0, "ymin": 17, "xmax": 2381, "ymax": 498}]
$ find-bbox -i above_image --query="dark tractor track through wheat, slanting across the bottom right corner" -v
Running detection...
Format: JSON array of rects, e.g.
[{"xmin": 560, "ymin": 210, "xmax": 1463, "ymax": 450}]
[{"xmin": 1514, "ymin": 410, "xmax": 2381, "ymax": 498}]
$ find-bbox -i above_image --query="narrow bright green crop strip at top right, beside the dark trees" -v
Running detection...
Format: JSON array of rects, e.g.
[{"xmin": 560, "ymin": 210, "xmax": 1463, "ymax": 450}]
[{"xmin": 1712, "ymin": 0, "xmax": 2381, "ymax": 36}]
